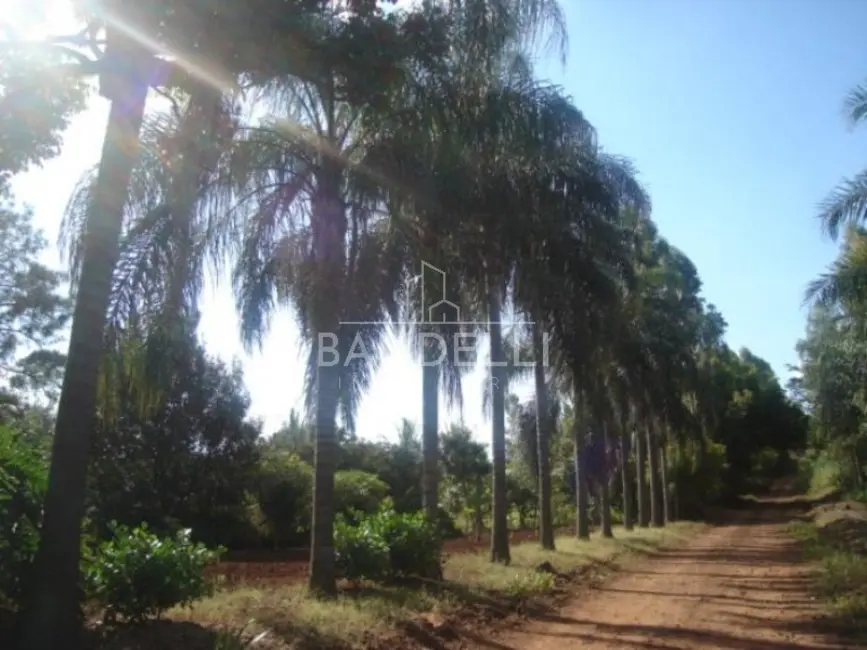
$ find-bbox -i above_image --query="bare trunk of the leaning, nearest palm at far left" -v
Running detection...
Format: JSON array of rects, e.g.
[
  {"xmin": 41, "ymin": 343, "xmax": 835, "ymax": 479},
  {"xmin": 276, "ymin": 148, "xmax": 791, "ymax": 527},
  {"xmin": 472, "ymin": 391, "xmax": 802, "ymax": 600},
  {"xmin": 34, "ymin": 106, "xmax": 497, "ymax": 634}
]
[{"xmin": 21, "ymin": 46, "xmax": 149, "ymax": 650}]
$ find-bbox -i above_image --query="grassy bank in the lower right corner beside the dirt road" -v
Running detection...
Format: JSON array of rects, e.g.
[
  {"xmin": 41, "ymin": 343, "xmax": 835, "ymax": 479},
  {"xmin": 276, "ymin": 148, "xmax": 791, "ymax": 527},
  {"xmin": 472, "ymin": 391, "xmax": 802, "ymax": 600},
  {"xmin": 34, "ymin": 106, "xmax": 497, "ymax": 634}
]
[{"xmin": 789, "ymin": 522, "xmax": 867, "ymax": 641}]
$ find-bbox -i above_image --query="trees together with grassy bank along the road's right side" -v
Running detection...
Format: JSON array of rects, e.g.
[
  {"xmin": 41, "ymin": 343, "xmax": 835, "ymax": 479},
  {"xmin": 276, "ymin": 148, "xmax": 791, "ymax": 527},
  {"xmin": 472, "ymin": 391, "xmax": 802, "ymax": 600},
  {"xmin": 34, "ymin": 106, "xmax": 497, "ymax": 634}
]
[{"xmin": 790, "ymin": 71, "xmax": 867, "ymax": 640}]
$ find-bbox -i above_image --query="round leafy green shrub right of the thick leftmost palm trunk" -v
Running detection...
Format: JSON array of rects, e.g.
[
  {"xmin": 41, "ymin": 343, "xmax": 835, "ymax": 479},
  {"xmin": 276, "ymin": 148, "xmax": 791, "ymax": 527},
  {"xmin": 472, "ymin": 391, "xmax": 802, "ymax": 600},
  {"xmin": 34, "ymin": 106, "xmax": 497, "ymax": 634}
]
[{"xmin": 85, "ymin": 525, "xmax": 223, "ymax": 621}]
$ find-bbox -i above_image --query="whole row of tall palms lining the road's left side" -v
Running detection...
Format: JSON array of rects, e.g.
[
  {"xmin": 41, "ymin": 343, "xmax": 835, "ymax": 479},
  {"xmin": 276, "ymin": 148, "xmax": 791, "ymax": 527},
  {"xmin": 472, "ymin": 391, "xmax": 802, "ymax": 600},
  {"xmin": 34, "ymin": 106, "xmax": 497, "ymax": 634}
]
[{"xmin": 17, "ymin": 0, "xmax": 721, "ymax": 650}]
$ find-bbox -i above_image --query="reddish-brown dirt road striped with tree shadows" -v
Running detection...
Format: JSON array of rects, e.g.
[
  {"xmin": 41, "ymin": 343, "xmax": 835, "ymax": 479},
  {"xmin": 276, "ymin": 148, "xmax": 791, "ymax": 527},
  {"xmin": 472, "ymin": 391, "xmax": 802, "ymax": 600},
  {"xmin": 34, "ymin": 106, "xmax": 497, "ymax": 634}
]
[{"xmin": 477, "ymin": 504, "xmax": 855, "ymax": 650}]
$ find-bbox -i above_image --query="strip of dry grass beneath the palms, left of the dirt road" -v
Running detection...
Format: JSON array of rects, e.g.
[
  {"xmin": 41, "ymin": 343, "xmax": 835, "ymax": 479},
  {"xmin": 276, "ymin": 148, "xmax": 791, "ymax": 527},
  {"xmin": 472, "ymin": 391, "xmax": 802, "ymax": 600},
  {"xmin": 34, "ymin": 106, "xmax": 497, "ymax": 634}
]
[{"xmin": 170, "ymin": 523, "xmax": 701, "ymax": 650}]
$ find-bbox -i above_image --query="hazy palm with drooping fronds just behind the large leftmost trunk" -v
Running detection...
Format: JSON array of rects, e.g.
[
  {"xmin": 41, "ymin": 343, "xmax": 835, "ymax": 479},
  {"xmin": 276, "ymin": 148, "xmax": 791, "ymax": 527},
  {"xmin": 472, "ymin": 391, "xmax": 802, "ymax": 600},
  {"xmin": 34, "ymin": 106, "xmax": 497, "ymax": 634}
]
[{"xmin": 61, "ymin": 83, "xmax": 235, "ymax": 417}]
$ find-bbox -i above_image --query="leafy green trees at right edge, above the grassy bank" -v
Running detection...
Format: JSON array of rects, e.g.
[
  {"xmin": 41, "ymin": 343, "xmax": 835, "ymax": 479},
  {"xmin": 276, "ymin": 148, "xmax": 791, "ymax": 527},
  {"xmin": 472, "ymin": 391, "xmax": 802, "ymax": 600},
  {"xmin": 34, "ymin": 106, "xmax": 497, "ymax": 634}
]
[{"xmin": 791, "ymin": 76, "xmax": 867, "ymax": 498}]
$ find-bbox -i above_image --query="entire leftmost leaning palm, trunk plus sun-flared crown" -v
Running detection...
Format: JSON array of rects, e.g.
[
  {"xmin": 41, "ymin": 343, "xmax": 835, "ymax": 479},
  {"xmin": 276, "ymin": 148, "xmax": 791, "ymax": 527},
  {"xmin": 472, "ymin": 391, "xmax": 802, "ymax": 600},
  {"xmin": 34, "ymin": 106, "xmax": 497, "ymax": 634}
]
[{"xmin": 22, "ymin": 3, "xmax": 294, "ymax": 636}]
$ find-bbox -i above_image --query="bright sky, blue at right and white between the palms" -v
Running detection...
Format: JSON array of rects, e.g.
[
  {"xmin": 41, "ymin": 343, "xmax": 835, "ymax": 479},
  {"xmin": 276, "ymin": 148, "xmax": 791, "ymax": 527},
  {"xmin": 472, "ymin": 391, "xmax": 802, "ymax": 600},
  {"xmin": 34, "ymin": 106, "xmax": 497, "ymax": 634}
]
[{"xmin": 6, "ymin": 0, "xmax": 867, "ymax": 439}]
